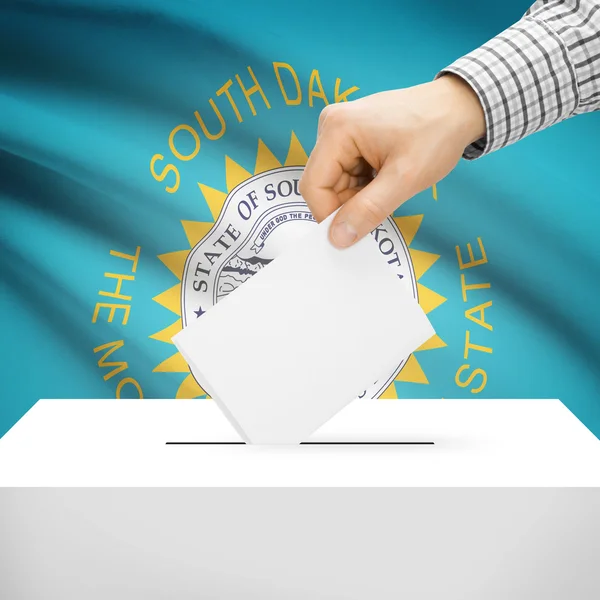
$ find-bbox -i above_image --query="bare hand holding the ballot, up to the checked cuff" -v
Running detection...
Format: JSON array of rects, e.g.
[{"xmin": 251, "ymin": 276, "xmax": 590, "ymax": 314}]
[{"xmin": 300, "ymin": 75, "xmax": 485, "ymax": 248}]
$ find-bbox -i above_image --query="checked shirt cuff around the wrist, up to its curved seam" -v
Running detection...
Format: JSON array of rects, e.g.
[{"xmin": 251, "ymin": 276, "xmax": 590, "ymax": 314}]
[{"xmin": 436, "ymin": 16, "xmax": 579, "ymax": 160}]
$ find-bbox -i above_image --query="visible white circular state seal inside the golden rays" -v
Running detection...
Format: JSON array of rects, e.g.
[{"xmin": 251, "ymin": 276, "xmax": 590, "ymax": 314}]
[{"xmin": 181, "ymin": 166, "xmax": 418, "ymax": 398}]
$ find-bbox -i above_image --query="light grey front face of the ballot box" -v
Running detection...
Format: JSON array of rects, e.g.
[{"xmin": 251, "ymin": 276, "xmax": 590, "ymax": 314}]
[{"xmin": 0, "ymin": 488, "xmax": 600, "ymax": 600}]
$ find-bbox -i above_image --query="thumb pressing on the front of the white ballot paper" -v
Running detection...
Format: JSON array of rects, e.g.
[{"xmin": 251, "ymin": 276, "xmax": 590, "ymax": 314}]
[{"xmin": 329, "ymin": 165, "xmax": 413, "ymax": 248}]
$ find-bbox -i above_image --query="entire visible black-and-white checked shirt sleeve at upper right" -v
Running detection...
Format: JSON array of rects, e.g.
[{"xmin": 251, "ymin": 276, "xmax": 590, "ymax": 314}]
[{"xmin": 437, "ymin": 0, "xmax": 600, "ymax": 160}]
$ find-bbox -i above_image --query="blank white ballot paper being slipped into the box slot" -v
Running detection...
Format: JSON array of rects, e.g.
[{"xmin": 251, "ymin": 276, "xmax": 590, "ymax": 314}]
[{"xmin": 173, "ymin": 215, "xmax": 435, "ymax": 444}]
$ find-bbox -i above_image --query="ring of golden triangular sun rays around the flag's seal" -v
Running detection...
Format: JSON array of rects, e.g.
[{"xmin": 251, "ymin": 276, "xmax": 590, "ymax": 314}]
[{"xmin": 150, "ymin": 132, "xmax": 446, "ymax": 399}]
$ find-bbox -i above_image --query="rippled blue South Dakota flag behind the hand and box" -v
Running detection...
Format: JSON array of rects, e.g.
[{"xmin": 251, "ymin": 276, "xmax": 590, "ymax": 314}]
[{"xmin": 0, "ymin": 0, "xmax": 600, "ymax": 435}]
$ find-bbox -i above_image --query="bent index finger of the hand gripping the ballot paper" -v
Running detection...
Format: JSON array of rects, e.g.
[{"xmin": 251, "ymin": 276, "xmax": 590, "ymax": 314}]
[{"xmin": 300, "ymin": 106, "xmax": 363, "ymax": 222}]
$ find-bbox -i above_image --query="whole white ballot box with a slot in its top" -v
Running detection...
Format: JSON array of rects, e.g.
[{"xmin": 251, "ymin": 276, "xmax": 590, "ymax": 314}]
[{"xmin": 0, "ymin": 400, "xmax": 600, "ymax": 600}]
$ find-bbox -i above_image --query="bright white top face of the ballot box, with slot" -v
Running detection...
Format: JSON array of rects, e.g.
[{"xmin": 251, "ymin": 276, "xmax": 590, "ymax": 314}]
[{"xmin": 0, "ymin": 400, "xmax": 600, "ymax": 487}]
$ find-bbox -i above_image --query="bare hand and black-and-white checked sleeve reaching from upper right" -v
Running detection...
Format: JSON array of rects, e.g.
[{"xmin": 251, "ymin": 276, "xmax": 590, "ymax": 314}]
[{"xmin": 300, "ymin": 0, "xmax": 600, "ymax": 247}]
